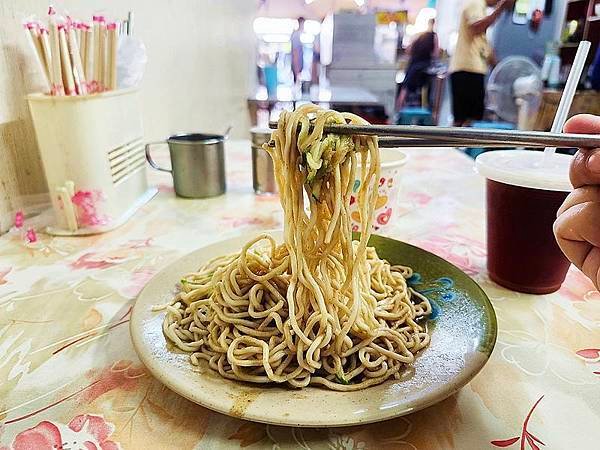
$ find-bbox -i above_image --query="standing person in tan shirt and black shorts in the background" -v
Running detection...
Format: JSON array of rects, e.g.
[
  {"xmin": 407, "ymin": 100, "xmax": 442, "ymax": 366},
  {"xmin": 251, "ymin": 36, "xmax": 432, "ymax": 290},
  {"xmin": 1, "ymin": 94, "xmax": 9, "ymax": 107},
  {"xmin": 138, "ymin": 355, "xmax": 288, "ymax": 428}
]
[{"xmin": 450, "ymin": 0, "xmax": 514, "ymax": 126}]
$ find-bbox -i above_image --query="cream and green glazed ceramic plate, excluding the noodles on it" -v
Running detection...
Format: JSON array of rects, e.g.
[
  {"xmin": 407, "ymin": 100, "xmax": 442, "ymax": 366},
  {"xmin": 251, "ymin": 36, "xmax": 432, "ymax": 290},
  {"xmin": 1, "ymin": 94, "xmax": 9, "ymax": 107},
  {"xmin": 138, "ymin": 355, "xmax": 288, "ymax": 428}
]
[{"xmin": 131, "ymin": 233, "xmax": 496, "ymax": 427}]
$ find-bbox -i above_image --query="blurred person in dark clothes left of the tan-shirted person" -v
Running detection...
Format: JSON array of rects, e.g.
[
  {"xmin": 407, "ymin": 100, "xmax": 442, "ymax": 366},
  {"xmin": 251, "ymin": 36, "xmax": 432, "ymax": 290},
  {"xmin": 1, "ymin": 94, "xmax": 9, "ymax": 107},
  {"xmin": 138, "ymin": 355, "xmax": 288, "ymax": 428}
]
[{"xmin": 396, "ymin": 19, "xmax": 439, "ymax": 111}]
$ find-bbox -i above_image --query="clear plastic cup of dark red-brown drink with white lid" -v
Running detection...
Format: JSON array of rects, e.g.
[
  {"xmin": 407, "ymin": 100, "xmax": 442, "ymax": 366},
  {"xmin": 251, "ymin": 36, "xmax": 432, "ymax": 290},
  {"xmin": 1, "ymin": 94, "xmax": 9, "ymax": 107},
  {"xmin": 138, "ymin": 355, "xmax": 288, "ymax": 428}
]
[{"xmin": 475, "ymin": 150, "xmax": 572, "ymax": 294}]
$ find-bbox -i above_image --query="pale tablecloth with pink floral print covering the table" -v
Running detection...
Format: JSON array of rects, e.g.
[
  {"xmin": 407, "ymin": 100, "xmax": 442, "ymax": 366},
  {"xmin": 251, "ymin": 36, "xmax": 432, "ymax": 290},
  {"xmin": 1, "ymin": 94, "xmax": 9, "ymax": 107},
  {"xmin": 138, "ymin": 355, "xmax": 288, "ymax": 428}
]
[{"xmin": 0, "ymin": 141, "xmax": 600, "ymax": 450}]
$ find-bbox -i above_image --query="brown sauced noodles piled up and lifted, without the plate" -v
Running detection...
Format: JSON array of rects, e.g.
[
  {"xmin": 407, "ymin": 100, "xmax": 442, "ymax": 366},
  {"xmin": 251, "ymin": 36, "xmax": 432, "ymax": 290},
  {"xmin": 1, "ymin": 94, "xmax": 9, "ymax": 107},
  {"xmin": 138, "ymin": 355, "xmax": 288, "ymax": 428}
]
[{"xmin": 163, "ymin": 104, "xmax": 431, "ymax": 391}]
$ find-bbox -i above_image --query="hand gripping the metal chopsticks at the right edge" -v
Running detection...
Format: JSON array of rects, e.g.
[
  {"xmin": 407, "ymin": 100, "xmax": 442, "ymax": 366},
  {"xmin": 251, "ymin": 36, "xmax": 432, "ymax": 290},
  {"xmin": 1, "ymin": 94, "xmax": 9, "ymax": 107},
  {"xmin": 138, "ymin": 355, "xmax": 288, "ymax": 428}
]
[{"xmin": 554, "ymin": 114, "xmax": 600, "ymax": 289}]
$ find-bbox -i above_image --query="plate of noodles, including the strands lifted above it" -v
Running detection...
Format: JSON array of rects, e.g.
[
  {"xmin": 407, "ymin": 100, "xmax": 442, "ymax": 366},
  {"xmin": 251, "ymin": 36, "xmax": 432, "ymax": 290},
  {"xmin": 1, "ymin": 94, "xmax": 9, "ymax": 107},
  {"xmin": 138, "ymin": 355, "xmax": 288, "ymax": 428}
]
[{"xmin": 130, "ymin": 105, "xmax": 497, "ymax": 427}]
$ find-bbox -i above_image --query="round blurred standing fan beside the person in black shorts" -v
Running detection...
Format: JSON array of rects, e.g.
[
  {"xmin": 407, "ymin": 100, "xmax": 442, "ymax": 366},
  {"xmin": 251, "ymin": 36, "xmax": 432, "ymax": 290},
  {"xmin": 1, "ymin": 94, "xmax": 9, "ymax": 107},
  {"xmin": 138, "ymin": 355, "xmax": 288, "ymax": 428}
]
[{"xmin": 487, "ymin": 56, "xmax": 543, "ymax": 130}]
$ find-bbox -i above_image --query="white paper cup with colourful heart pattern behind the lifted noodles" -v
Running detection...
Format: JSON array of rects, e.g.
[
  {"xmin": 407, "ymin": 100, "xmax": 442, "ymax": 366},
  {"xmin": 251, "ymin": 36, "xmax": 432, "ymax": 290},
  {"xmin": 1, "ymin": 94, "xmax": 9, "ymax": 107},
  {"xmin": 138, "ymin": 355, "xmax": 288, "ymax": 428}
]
[{"xmin": 350, "ymin": 148, "xmax": 408, "ymax": 231}]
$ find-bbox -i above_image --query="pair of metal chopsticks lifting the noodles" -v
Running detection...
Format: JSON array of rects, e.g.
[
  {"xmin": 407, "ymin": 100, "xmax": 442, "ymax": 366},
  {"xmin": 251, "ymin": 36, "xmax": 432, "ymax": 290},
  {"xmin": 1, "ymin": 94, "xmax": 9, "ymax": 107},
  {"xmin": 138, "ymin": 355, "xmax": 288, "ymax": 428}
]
[{"xmin": 269, "ymin": 122, "xmax": 600, "ymax": 148}]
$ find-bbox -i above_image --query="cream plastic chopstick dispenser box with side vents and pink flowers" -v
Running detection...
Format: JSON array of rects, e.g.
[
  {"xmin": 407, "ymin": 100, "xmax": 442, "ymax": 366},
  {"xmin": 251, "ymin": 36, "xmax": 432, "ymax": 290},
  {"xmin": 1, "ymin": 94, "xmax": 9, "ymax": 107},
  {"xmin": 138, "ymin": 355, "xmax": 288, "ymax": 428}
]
[{"xmin": 27, "ymin": 89, "xmax": 157, "ymax": 235}]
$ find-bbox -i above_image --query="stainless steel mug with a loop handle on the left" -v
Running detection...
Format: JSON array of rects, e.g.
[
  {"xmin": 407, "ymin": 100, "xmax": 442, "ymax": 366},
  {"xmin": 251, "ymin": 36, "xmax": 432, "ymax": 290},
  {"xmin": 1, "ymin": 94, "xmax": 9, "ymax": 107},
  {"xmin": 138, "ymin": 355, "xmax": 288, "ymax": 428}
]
[{"xmin": 146, "ymin": 133, "xmax": 227, "ymax": 198}]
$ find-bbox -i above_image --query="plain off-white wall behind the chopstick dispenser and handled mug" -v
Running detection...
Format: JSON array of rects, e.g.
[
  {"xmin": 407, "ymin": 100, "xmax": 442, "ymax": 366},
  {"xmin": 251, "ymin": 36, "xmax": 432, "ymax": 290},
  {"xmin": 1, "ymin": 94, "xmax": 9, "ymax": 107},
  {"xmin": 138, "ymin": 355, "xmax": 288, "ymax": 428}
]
[{"xmin": 0, "ymin": 0, "xmax": 257, "ymax": 232}]
